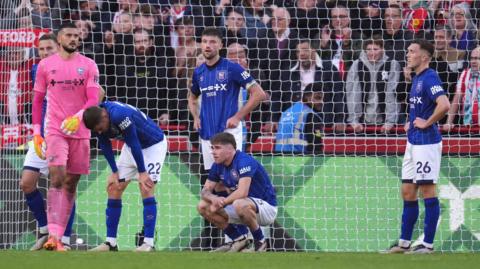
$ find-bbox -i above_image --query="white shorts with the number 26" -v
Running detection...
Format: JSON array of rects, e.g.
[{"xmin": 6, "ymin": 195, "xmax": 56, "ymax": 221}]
[{"xmin": 402, "ymin": 142, "xmax": 442, "ymax": 185}]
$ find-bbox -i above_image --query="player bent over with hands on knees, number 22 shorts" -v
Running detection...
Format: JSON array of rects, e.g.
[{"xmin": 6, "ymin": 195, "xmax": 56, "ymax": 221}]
[{"xmin": 83, "ymin": 102, "xmax": 167, "ymax": 251}]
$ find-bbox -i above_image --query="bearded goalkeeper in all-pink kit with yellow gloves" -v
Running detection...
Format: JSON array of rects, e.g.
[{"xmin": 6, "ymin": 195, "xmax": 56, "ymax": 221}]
[{"xmin": 32, "ymin": 23, "xmax": 100, "ymax": 251}]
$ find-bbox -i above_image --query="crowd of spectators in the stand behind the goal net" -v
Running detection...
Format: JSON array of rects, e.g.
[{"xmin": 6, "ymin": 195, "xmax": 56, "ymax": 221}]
[{"xmin": 0, "ymin": 0, "xmax": 480, "ymax": 151}]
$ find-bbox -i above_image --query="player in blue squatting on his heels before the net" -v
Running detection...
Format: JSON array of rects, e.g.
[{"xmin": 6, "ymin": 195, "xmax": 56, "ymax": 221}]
[{"xmin": 197, "ymin": 132, "xmax": 277, "ymax": 252}]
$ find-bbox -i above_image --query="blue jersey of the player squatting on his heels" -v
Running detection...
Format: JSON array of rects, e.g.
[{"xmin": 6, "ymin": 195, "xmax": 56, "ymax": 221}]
[{"xmin": 208, "ymin": 151, "xmax": 277, "ymax": 206}]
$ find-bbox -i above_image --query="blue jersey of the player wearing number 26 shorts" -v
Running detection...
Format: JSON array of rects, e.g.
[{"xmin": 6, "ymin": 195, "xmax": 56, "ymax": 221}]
[{"xmin": 407, "ymin": 68, "xmax": 445, "ymax": 145}]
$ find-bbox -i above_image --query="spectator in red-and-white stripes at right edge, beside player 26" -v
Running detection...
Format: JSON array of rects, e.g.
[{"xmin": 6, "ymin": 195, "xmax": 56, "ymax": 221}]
[{"xmin": 443, "ymin": 47, "xmax": 480, "ymax": 131}]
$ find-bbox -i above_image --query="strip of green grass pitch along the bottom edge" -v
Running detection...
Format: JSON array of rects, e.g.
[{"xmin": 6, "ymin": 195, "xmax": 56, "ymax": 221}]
[{"xmin": 0, "ymin": 250, "xmax": 480, "ymax": 269}]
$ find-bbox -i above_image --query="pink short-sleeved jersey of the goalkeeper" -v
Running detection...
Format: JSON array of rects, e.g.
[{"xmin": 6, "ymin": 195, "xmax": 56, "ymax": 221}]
[{"xmin": 34, "ymin": 52, "xmax": 100, "ymax": 139}]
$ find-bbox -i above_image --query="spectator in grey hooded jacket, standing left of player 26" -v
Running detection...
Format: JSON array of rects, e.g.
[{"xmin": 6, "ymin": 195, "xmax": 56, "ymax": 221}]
[{"xmin": 346, "ymin": 39, "xmax": 401, "ymax": 133}]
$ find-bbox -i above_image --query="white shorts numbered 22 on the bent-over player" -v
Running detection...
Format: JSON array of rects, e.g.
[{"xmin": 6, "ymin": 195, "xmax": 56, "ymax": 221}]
[{"xmin": 117, "ymin": 137, "xmax": 168, "ymax": 182}]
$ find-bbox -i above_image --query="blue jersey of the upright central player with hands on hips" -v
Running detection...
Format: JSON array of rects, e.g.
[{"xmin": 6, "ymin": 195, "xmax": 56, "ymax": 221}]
[{"xmin": 192, "ymin": 58, "xmax": 255, "ymax": 140}]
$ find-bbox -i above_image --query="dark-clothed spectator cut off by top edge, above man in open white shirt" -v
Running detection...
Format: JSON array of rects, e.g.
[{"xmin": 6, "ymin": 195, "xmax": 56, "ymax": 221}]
[{"xmin": 283, "ymin": 0, "xmax": 328, "ymax": 39}]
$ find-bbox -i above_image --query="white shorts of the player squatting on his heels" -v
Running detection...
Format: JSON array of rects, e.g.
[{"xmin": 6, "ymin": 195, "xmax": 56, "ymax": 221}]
[{"xmin": 224, "ymin": 197, "xmax": 278, "ymax": 226}]
